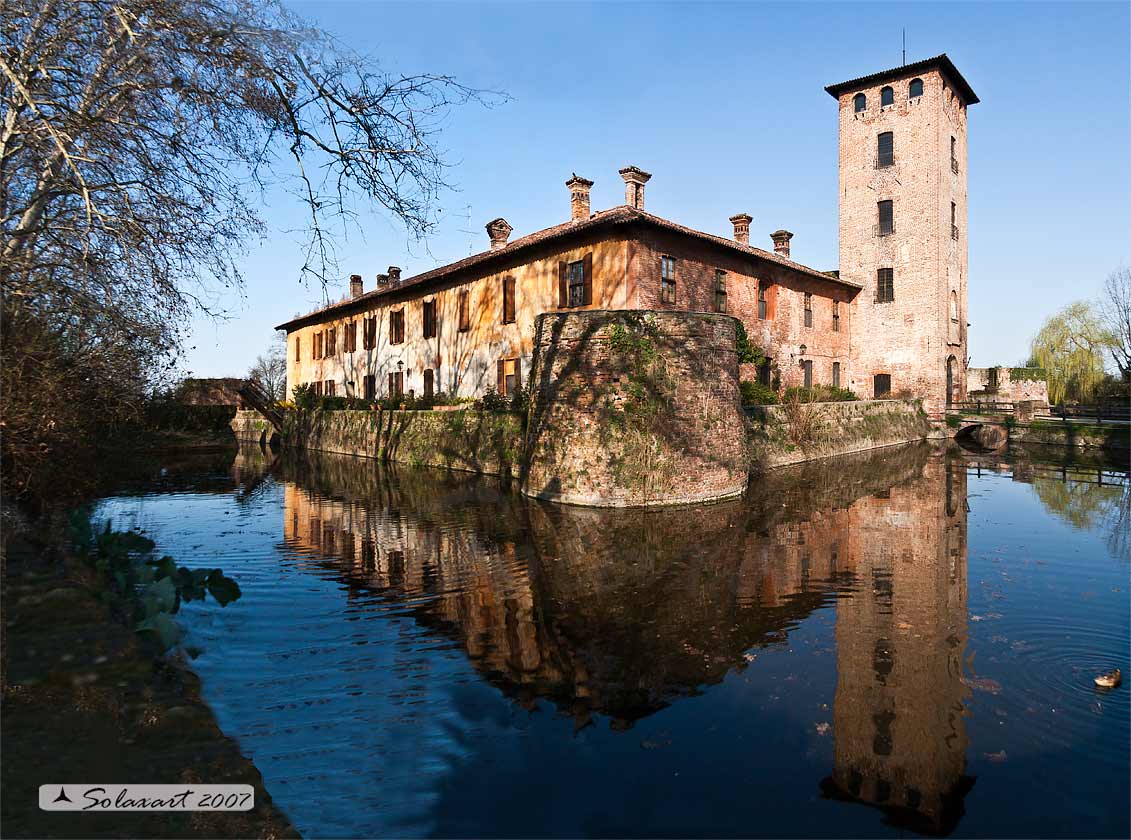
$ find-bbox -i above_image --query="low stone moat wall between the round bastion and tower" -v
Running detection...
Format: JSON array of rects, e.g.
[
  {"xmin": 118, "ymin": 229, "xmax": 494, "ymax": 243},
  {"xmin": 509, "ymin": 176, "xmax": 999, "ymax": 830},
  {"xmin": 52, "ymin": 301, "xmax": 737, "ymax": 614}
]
[{"xmin": 746, "ymin": 399, "xmax": 931, "ymax": 473}]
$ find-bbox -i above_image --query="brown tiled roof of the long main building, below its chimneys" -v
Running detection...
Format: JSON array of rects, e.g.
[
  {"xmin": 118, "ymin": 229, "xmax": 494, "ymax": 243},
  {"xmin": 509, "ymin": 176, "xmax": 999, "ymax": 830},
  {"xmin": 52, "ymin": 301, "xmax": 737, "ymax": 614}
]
[{"xmin": 275, "ymin": 205, "xmax": 861, "ymax": 330}]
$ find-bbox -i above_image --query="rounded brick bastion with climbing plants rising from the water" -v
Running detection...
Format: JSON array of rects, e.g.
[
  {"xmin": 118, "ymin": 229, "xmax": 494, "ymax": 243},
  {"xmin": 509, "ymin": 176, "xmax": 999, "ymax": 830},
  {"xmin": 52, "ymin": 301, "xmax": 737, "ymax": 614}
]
[{"xmin": 520, "ymin": 310, "xmax": 749, "ymax": 508}]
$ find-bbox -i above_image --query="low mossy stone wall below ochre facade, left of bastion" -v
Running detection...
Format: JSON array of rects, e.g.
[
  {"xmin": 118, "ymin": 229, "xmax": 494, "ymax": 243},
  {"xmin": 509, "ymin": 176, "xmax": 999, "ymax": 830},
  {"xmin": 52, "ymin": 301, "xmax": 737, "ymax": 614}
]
[{"xmin": 283, "ymin": 410, "xmax": 523, "ymax": 477}]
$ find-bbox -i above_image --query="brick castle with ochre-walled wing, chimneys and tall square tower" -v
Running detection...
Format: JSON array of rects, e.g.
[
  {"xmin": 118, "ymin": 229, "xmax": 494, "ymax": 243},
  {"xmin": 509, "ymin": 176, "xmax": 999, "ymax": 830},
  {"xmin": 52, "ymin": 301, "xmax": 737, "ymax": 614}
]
[{"xmin": 277, "ymin": 54, "xmax": 978, "ymax": 412}]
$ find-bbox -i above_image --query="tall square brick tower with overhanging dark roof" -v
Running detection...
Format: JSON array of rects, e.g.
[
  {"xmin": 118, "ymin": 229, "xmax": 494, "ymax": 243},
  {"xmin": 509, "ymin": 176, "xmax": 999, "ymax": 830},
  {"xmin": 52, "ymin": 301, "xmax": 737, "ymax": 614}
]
[{"xmin": 826, "ymin": 55, "xmax": 978, "ymax": 413}]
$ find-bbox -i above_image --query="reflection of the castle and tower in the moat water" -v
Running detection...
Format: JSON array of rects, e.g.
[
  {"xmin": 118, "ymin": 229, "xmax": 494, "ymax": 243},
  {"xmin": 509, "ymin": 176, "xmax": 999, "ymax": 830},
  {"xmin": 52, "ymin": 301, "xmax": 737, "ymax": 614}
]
[{"xmin": 273, "ymin": 447, "xmax": 969, "ymax": 833}]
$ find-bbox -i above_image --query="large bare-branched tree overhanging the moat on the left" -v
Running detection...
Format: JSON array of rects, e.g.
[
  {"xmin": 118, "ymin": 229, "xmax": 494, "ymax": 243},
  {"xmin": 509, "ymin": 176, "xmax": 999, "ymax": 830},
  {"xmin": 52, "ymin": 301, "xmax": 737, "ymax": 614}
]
[{"xmin": 0, "ymin": 0, "xmax": 495, "ymax": 499}]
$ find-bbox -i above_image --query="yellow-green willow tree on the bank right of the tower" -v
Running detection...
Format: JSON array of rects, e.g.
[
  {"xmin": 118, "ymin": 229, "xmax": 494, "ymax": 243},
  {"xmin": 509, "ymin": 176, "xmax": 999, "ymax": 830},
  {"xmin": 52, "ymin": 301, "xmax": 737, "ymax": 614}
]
[{"xmin": 1030, "ymin": 302, "xmax": 1114, "ymax": 402}]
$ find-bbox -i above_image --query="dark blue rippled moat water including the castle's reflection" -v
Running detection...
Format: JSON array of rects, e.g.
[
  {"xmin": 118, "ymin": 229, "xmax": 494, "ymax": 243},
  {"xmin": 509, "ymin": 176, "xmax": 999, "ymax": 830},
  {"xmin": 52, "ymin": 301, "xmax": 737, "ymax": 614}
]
[{"xmin": 102, "ymin": 447, "xmax": 1131, "ymax": 837}]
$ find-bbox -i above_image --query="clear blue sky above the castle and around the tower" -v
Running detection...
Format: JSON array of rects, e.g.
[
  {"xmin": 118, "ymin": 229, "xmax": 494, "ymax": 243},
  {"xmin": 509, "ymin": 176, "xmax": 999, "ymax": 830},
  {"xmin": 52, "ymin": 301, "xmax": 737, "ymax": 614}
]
[{"xmin": 185, "ymin": 2, "xmax": 1131, "ymax": 376}]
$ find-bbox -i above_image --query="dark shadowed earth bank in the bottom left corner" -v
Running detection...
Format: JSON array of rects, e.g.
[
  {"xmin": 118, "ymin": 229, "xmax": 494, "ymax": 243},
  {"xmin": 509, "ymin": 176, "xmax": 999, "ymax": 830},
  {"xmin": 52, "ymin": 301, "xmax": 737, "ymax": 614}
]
[{"xmin": 0, "ymin": 511, "xmax": 297, "ymax": 838}]
